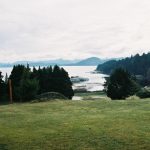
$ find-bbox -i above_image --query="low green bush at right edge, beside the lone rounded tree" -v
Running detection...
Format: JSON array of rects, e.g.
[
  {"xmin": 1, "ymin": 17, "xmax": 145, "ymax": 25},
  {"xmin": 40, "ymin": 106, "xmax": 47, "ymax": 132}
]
[{"xmin": 136, "ymin": 87, "xmax": 150, "ymax": 98}]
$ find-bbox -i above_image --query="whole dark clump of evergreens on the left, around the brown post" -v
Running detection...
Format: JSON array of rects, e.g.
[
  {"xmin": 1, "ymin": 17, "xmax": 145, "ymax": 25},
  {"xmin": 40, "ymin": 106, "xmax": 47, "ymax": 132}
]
[{"xmin": 0, "ymin": 65, "xmax": 74, "ymax": 102}]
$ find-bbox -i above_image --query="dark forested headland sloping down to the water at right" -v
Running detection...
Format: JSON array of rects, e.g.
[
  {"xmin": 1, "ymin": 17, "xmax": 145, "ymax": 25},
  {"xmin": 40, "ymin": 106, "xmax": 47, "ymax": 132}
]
[{"xmin": 97, "ymin": 53, "xmax": 150, "ymax": 77}]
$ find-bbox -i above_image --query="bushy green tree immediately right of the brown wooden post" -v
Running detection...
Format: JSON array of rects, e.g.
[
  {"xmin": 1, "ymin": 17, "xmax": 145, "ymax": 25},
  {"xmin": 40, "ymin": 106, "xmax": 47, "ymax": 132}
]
[{"xmin": 10, "ymin": 65, "xmax": 38, "ymax": 102}]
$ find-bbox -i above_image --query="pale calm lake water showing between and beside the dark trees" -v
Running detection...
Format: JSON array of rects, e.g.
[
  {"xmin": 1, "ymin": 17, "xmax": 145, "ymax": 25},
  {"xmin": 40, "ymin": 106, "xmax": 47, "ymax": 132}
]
[{"xmin": 0, "ymin": 66, "xmax": 106, "ymax": 91}]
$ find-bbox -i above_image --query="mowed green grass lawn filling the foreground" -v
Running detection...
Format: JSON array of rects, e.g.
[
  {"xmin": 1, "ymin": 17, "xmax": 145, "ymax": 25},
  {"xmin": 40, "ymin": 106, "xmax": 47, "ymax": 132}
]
[{"xmin": 0, "ymin": 99, "xmax": 150, "ymax": 150}]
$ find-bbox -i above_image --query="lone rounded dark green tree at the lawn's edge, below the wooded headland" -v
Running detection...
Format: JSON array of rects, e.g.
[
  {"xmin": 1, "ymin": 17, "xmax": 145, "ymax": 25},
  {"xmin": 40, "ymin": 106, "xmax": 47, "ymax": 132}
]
[{"xmin": 105, "ymin": 68, "xmax": 139, "ymax": 100}]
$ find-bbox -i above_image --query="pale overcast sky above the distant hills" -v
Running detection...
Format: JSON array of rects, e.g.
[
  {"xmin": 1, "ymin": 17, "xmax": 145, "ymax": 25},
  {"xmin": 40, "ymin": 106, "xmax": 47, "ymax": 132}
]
[{"xmin": 0, "ymin": 0, "xmax": 150, "ymax": 62}]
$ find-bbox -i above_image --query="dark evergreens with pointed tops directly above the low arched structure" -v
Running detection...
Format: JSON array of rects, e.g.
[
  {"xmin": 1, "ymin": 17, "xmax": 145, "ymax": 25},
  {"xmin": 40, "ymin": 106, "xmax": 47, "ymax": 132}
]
[{"xmin": 31, "ymin": 65, "xmax": 74, "ymax": 99}]
